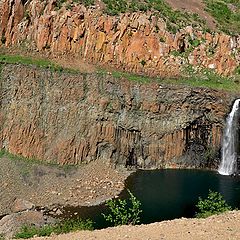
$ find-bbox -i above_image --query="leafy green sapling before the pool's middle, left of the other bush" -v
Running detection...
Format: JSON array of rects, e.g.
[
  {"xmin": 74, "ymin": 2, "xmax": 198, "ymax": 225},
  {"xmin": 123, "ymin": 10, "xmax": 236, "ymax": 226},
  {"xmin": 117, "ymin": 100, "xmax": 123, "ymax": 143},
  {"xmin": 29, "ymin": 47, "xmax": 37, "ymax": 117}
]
[{"xmin": 102, "ymin": 190, "xmax": 142, "ymax": 226}]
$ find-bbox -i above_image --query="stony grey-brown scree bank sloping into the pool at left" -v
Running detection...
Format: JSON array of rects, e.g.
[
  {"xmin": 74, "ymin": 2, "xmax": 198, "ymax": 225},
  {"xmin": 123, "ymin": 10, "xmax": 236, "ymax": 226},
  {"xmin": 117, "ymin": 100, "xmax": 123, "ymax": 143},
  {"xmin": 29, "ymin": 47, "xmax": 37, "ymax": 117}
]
[{"xmin": 0, "ymin": 156, "xmax": 133, "ymax": 217}]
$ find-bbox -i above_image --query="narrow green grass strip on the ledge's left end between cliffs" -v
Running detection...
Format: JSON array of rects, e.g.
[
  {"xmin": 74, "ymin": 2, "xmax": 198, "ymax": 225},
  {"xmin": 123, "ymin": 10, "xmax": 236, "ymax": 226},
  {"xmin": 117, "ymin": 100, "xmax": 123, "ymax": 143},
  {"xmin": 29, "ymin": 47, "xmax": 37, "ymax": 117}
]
[{"xmin": 0, "ymin": 54, "xmax": 79, "ymax": 73}]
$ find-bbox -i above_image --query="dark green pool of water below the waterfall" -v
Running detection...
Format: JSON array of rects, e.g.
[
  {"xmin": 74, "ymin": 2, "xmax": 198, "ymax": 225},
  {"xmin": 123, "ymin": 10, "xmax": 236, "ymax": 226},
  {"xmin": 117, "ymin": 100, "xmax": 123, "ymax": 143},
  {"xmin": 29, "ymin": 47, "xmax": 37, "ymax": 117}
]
[{"xmin": 60, "ymin": 170, "xmax": 240, "ymax": 228}]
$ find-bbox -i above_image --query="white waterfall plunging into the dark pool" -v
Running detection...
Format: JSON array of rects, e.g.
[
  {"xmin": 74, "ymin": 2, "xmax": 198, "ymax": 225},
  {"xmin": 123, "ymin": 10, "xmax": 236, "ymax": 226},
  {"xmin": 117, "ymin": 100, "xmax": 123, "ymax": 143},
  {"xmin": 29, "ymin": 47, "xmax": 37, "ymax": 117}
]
[{"xmin": 218, "ymin": 99, "xmax": 240, "ymax": 175}]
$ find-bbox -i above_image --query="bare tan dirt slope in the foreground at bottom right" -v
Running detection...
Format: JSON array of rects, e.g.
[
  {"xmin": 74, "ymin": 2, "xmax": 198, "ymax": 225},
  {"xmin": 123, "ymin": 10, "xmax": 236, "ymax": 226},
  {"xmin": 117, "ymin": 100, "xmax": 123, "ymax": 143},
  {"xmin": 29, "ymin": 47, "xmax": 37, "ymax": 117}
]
[{"xmin": 30, "ymin": 211, "xmax": 240, "ymax": 240}]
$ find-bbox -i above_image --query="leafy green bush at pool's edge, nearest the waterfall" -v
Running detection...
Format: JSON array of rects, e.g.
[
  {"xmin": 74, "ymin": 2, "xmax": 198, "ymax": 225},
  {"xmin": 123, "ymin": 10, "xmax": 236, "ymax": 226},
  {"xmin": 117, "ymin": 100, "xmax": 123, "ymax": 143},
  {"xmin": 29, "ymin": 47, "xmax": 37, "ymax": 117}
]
[{"xmin": 196, "ymin": 190, "xmax": 232, "ymax": 218}]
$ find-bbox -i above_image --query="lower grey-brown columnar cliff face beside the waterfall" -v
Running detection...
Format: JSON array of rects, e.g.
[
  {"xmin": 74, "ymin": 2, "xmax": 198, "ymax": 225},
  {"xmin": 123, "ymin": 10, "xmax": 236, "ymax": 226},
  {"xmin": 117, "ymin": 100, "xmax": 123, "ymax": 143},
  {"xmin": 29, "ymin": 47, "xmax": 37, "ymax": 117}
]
[{"xmin": 1, "ymin": 65, "xmax": 232, "ymax": 168}]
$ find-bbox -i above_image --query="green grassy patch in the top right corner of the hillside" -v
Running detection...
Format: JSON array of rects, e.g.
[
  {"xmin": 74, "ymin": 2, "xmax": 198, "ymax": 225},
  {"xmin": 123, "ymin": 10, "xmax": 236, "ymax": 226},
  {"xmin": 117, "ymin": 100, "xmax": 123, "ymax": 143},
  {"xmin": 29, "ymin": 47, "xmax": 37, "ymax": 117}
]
[{"xmin": 205, "ymin": 0, "xmax": 240, "ymax": 34}]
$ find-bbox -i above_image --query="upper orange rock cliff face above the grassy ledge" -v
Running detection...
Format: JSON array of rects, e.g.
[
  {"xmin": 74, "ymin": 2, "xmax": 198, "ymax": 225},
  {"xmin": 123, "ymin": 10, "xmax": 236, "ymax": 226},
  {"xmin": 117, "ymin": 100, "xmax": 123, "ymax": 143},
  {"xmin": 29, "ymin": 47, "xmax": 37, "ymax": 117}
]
[{"xmin": 0, "ymin": 0, "xmax": 240, "ymax": 76}]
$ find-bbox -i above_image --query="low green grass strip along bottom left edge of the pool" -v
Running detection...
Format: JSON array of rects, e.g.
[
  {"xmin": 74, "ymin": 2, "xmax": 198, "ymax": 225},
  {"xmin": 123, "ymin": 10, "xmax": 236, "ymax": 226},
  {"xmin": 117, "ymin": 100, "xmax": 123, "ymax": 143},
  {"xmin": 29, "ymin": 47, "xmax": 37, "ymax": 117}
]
[{"xmin": 15, "ymin": 218, "xmax": 93, "ymax": 239}]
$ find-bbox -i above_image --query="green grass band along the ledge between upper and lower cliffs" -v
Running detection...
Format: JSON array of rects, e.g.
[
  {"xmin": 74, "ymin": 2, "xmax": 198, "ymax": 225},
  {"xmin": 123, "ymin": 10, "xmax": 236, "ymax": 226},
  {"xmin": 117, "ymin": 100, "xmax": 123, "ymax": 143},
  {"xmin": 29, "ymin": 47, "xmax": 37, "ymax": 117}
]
[{"xmin": 0, "ymin": 54, "xmax": 240, "ymax": 92}]
